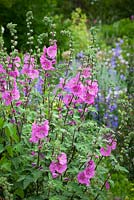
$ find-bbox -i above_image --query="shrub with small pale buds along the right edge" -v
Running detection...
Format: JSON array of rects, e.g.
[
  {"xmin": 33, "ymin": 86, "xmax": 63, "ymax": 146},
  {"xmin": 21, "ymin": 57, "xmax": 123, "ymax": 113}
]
[{"xmin": 118, "ymin": 94, "xmax": 134, "ymax": 180}]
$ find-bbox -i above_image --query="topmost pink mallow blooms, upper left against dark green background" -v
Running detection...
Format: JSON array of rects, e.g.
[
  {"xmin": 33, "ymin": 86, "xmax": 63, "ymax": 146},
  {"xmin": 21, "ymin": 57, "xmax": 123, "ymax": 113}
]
[{"xmin": 40, "ymin": 43, "xmax": 57, "ymax": 70}]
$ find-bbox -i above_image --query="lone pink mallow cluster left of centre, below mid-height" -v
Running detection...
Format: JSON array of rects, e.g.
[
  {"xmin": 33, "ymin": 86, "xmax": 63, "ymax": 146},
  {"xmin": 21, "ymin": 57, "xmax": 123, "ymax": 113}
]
[{"xmin": 29, "ymin": 120, "xmax": 49, "ymax": 143}]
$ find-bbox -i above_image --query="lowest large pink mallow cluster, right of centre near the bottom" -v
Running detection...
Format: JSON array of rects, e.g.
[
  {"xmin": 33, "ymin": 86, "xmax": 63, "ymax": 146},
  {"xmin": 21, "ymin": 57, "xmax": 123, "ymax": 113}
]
[{"xmin": 77, "ymin": 160, "xmax": 95, "ymax": 186}]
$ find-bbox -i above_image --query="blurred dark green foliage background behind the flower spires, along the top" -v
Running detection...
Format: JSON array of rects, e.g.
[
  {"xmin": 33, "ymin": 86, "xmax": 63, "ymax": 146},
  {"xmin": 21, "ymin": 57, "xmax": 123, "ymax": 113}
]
[{"xmin": 0, "ymin": 0, "xmax": 134, "ymax": 50}]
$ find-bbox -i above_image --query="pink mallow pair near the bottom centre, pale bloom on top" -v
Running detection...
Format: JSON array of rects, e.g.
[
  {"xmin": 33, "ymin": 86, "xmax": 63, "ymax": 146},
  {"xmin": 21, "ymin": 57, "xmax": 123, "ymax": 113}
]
[{"xmin": 49, "ymin": 152, "xmax": 67, "ymax": 178}]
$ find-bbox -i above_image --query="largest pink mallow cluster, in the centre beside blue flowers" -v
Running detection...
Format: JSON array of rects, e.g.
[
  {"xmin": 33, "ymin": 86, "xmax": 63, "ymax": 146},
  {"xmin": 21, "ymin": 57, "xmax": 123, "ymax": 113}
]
[{"xmin": 59, "ymin": 71, "xmax": 98, "ymax": 106}]
